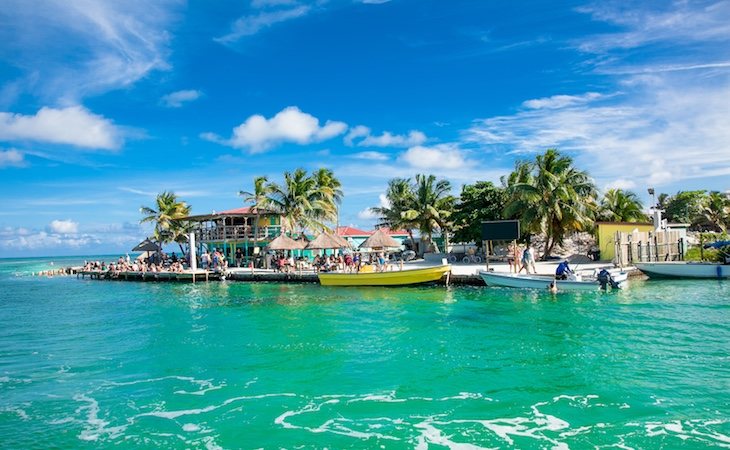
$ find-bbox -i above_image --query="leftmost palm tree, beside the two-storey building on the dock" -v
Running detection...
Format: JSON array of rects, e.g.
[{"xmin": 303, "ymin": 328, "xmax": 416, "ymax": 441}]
[{"xmin": 140, "ymin": 191, "xmax": 192, "ymax": 253}]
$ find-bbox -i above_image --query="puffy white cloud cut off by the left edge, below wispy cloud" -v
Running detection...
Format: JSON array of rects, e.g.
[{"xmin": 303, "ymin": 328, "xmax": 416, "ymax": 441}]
[{"xmin": 0, "ymin": 106, "xmax": 122, "ymax": 150}]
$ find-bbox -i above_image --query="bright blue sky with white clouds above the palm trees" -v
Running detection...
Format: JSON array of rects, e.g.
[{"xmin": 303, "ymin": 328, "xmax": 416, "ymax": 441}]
[{"xmin": 0, "ymin": 0, "xmax": 730, "ymax": 257}]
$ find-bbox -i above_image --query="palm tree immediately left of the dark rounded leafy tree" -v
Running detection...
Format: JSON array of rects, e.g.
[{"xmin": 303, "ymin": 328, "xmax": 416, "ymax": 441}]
[{"xmin": 401, "ymin": 174, "xmax": 455, "ymax": 255}]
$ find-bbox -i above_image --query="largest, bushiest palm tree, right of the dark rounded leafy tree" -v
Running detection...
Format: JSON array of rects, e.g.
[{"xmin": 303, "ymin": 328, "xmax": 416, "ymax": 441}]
[{"xmin": 505, "ymin": 149, "xmax": 596, "ymax": 259}]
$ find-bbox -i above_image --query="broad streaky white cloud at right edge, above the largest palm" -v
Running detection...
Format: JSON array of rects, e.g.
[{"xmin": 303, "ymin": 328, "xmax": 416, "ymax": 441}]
[{"xmin": 465, "ymin": 77, "xmax": 730, "ymax": 186}]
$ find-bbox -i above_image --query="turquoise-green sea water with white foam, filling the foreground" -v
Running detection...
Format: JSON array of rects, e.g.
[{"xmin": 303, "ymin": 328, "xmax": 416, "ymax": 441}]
[{"xmin": 0, "ymin": 255, "xmax": 730, "ymax": 449}]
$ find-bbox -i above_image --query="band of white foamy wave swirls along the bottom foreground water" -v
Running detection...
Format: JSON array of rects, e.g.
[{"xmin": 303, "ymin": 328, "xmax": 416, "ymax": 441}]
[{"xmin": 51, "ymin": 376, "xmax": 730, "ymax": 450}]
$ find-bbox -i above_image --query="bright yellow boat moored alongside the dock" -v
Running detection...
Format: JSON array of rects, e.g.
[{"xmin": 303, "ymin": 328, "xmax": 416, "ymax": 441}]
[{"xmin": 319, "ymin": 264, "xmax": 451, "ymax": 286}]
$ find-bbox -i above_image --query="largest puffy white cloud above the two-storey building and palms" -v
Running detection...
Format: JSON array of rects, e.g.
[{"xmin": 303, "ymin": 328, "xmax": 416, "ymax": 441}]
[{"xmin": 201, "ymin": 106, "xmax": 347, "ymax": 153}]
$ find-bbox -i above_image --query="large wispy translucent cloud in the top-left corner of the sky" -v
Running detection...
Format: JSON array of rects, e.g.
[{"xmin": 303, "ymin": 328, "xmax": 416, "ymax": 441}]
[{"xmin": 0, "ymin": 0, "xmax": 176, "ymax": 103}]
